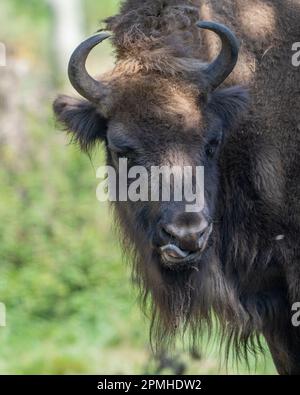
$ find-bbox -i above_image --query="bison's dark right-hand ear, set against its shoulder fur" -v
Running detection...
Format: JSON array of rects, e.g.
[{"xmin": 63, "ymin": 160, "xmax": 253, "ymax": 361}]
[{"xmin": 208, "ymin": 86, "xmax": 249, "ymax": 130}]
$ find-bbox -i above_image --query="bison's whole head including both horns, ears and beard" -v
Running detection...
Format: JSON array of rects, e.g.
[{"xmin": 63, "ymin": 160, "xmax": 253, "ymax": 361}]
[{"xmin": 54, "ymin": 22, "xmax": 247, "ymax": 350}]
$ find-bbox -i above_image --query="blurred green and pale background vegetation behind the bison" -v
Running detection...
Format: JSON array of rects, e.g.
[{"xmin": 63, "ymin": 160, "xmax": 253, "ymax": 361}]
[{"xmin": 0, "ymin": 0, "xmax": 275, "ymax": 374}]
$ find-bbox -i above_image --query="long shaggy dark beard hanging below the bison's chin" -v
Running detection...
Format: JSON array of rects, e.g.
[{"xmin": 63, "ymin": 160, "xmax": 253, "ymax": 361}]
[{"xmin": 115, "ymin": 204, "xmax": 274, "ymax": 363}]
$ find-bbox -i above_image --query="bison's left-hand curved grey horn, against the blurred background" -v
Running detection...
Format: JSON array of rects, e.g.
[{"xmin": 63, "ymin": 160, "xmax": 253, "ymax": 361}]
[{"xmin": 68, "ymin": 33, "xmax": 110, "ymax": 103}]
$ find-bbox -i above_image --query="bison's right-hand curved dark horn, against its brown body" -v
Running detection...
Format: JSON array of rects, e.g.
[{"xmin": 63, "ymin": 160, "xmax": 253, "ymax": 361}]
[{"xmin": 197, "ymin": 21, "xmax": 240, "ymax": 90}]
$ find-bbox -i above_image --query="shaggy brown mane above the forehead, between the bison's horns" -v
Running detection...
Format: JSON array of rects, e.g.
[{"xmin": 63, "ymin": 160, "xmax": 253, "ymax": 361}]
[{"xmin": 106, "ymin": 0, "xmax": 203, "ymax": 84}]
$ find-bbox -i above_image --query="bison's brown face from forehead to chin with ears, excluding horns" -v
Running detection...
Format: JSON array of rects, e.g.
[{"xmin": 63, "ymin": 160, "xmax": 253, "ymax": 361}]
[{"xmin": 54, "ymin": 75, "xmax": 246, "ymax": 270}]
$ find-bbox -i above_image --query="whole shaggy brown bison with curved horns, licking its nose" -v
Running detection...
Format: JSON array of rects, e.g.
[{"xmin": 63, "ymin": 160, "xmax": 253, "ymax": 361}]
[{"xmin": 54, "ymin": 0, "xmax": 300, "ymax": 374}]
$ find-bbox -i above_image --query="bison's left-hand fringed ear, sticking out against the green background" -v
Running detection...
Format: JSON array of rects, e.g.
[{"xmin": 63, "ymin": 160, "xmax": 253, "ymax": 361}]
[{"xmin": 53, "ymin": 96, "xmax": 107, "ymax": 152}]
